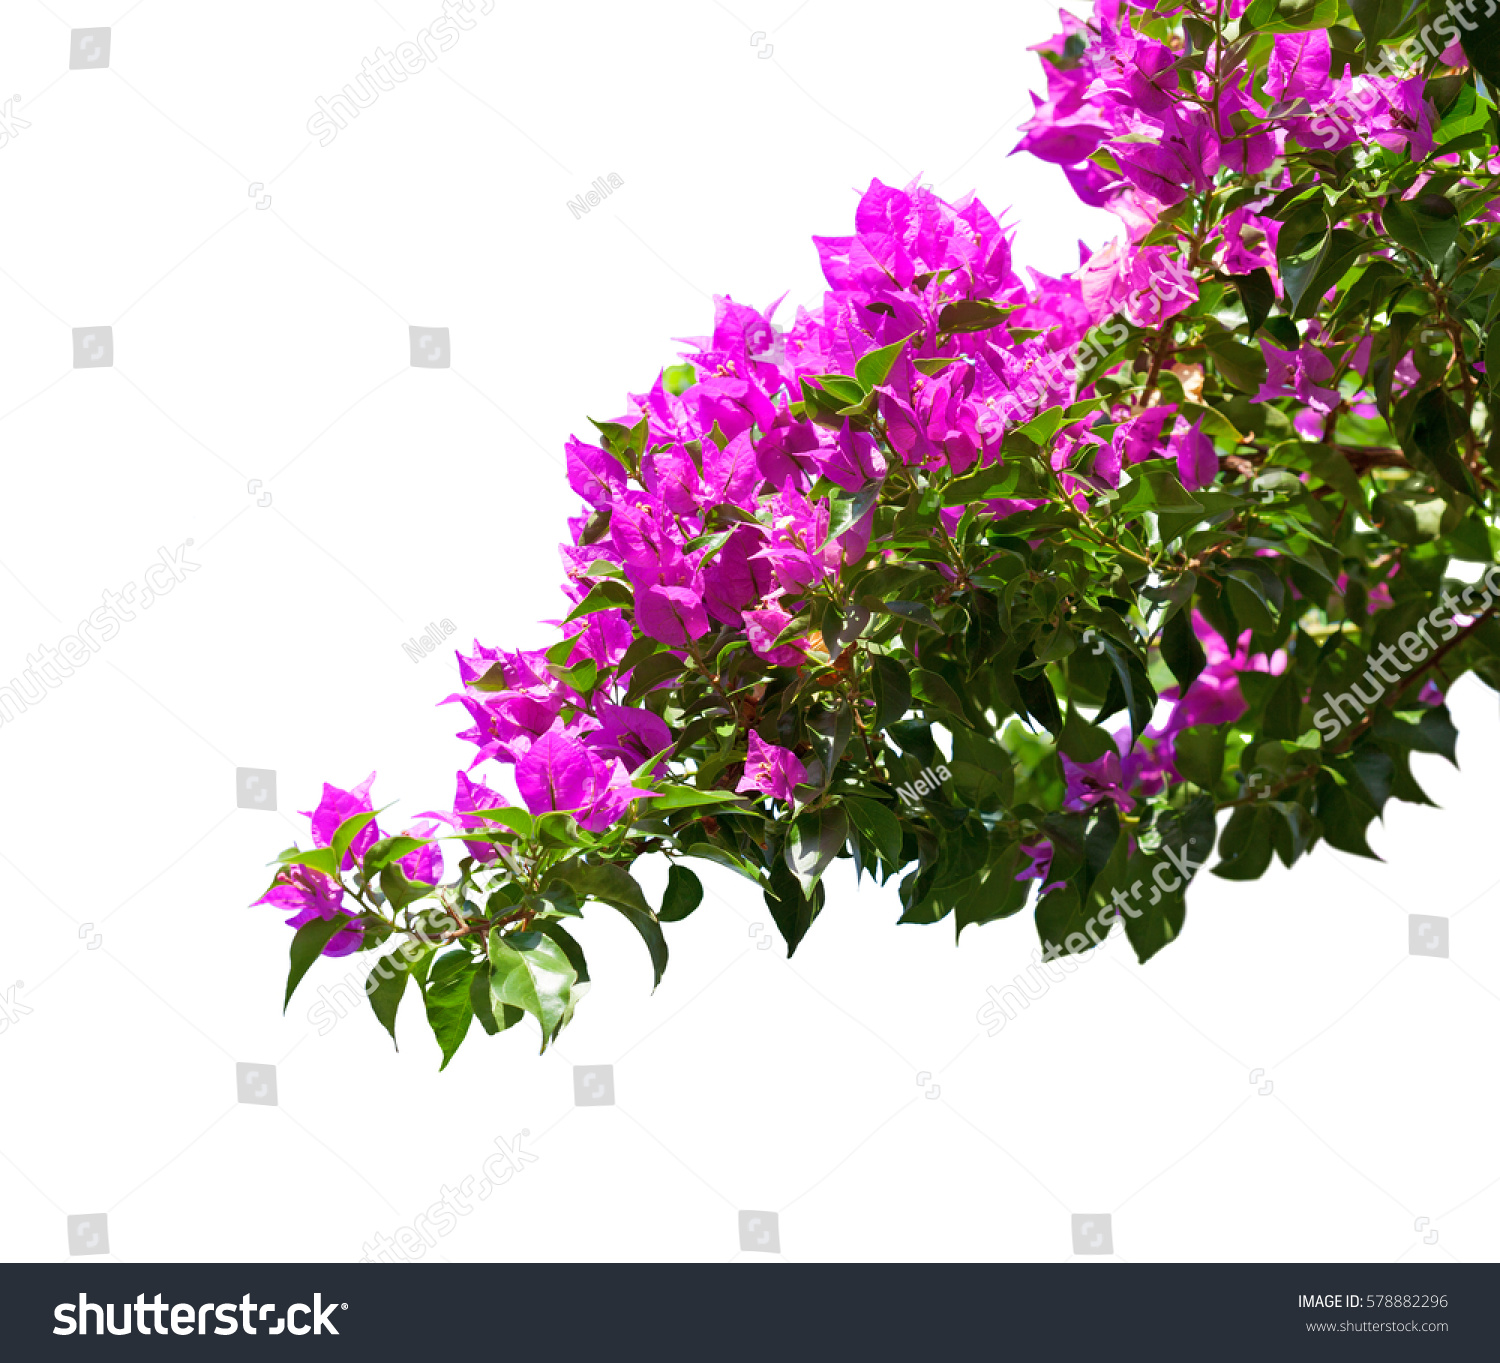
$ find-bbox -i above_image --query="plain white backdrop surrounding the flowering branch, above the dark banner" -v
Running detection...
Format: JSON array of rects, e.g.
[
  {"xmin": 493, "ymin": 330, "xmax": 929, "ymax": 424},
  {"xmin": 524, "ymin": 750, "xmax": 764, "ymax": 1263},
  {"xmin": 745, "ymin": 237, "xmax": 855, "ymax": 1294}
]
[{"xmin": 0, "ymin": 0, "xmax": 1500, "ymax": 1263}]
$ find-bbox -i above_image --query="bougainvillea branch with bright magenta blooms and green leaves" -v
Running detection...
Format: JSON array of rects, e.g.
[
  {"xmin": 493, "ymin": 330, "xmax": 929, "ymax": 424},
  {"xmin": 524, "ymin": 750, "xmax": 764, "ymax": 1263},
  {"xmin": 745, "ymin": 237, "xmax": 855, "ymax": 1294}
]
[{"xmin": 260, "ymin": 0, "xmax": 1500, "ymax": 1065}]
